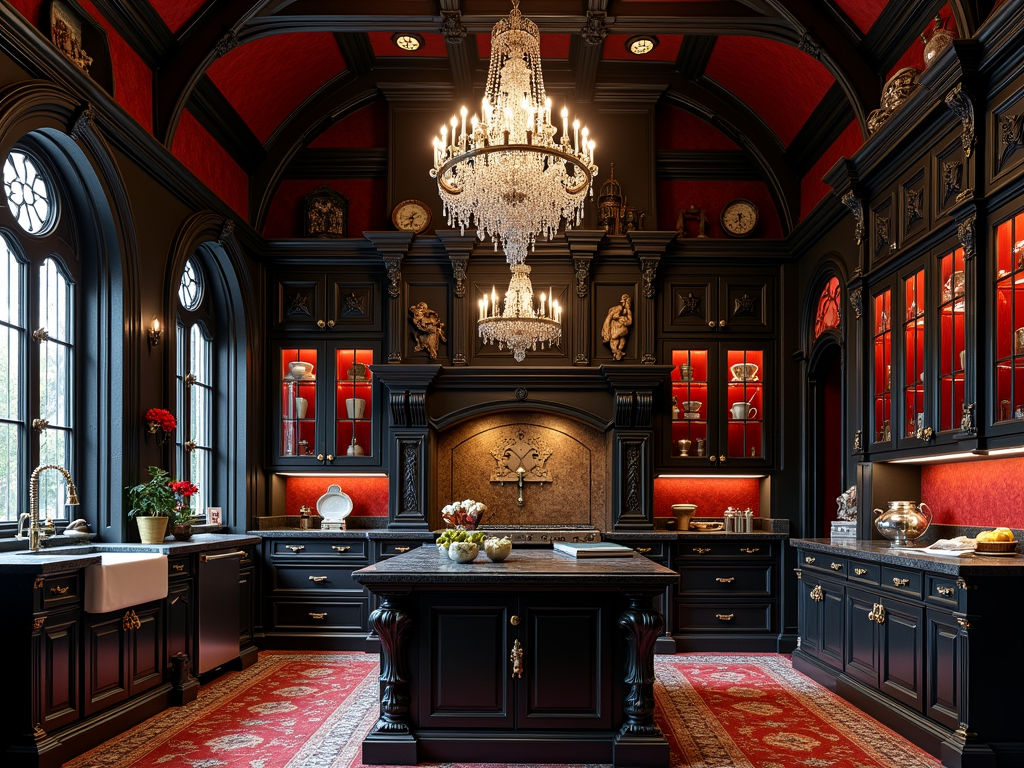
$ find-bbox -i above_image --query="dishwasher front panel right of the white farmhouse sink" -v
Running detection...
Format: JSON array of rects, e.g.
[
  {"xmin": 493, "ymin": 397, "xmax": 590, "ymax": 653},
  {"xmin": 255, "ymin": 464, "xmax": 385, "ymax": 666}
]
[{"xmin": 196, "ymin": 552, "xmax": 245, "ymax": 675}]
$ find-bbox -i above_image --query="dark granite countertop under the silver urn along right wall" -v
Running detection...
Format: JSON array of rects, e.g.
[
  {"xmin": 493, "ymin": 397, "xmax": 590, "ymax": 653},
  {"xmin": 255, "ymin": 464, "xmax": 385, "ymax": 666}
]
[{"xmin": 790, "ymin": 539, "xmax": 1024, "ymax": 575}]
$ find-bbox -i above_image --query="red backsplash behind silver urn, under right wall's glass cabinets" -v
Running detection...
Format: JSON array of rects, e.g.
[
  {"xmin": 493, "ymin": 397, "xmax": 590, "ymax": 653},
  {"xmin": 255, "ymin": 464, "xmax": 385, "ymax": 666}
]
[{"xmin": 921, "ymin": 458, "xmax": 1024, "ymax": 528}]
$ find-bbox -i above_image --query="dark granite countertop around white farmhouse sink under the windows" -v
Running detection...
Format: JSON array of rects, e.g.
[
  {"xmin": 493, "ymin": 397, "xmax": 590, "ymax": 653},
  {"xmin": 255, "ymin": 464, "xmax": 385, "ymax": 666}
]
[{"xmin": 0, "ymin": 534, "xmax": 260, "ymax": 573}]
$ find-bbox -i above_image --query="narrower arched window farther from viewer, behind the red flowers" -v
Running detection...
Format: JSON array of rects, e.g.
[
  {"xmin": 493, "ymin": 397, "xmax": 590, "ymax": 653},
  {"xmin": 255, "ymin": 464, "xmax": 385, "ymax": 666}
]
[{"xmin": 175, "ymin": 256, "xmax": 216, "ymax": 515}]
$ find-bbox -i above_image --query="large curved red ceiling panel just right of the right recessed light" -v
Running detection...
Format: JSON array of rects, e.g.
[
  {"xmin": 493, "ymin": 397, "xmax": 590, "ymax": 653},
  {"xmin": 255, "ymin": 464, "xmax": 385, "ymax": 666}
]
[{"xmin": 706, "ymin": 37, "xmax": 835, "ymax": 145}]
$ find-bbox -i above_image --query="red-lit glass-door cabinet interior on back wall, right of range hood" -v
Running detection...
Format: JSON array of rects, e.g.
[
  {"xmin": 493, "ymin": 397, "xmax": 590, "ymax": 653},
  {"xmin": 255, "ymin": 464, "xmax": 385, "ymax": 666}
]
[{"xmin": 669, "ymin": 344, "xmax": 770, "ymax": 470}]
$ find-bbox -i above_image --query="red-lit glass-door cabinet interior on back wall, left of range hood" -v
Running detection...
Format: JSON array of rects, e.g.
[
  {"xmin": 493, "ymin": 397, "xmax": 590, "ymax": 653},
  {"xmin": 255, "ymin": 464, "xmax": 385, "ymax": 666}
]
[{"xmin": 275, "ymin": 344, "xmax": 377, "ymax": 467}]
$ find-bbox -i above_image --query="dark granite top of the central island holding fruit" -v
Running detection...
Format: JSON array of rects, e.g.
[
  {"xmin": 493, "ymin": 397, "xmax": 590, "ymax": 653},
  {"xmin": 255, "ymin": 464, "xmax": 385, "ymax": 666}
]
[{"xmin": 352, "ymin": 547, "xmax": 679, "ymax": 592}]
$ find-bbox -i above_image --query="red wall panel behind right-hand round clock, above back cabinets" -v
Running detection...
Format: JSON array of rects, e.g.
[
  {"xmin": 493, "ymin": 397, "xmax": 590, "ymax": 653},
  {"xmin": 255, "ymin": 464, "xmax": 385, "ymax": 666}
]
[{"xmin": 647, "ymin": 180, "xmax": 782, "ymax": 238}]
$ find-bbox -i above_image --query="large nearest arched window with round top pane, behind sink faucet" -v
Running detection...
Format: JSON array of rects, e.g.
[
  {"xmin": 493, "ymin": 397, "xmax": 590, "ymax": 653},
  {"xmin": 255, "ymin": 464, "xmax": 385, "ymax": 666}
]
[{"xmin": 0, "ymin": 145, "xmax": 81, "ymax": 523}]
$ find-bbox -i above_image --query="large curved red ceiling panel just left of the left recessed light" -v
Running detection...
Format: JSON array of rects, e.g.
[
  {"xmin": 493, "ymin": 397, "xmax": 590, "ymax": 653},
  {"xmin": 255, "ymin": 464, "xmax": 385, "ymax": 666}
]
[{"xmin": 208, "ymin": 32, "xmax": 345, "ymax": 143}]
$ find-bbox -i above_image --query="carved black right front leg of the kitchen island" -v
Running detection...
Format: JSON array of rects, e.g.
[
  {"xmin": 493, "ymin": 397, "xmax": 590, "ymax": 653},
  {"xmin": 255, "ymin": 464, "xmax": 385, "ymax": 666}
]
[{"xmin": 612, "ymin": 594, "xmax": 669, "ymax": 768}]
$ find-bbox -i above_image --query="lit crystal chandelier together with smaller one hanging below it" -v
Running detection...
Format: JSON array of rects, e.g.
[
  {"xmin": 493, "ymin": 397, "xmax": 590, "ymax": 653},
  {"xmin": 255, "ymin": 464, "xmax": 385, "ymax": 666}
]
[{"xmin": 430, "ymin": 0, "xmax": 597, "ymax": 362}]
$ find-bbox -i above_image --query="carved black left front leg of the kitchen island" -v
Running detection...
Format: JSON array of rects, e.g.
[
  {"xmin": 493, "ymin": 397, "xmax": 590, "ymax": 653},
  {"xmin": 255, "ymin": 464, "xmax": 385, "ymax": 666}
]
[{"xmin": 362, "ymin": 595, "xmax": 417, "ymax": 765}]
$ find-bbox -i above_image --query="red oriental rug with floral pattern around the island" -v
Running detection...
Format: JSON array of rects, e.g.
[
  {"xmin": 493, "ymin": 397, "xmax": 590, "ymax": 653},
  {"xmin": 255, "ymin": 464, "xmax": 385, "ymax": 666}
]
[{"xmin": 65, "ymin": 652, "xmax": 941, "ymax": 768}]
